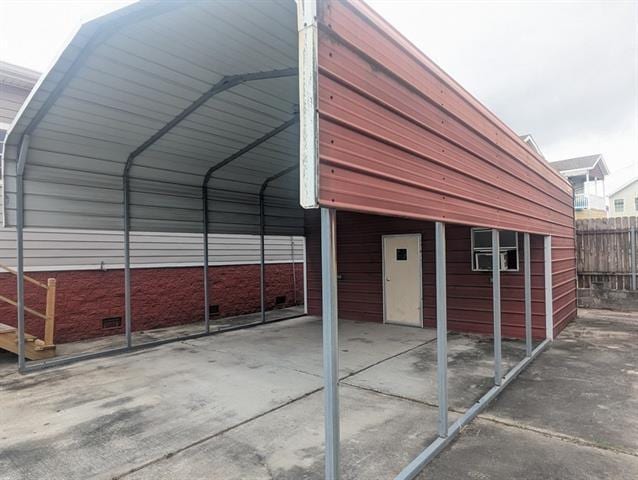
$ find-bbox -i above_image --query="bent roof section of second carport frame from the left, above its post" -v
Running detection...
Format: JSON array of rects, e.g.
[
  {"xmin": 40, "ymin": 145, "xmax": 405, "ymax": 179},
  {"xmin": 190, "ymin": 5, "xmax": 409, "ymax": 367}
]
[{"xmin": 124, "ymin": 68, "xmax": 297, "ymax": 176}]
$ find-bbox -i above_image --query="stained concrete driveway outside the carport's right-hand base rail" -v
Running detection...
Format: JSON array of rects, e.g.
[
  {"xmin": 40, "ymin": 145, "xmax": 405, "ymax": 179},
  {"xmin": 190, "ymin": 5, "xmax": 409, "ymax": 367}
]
[{"xmin": 419, "ymin": 309, "xmax": 638, "ymax": 480}]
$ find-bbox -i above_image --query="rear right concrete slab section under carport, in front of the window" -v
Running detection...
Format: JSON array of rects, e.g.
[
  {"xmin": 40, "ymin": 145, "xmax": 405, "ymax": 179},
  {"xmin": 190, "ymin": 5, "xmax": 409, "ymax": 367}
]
[{"xmin": 346, "ymin": 333, "xmax": 525, "ymax": 411}]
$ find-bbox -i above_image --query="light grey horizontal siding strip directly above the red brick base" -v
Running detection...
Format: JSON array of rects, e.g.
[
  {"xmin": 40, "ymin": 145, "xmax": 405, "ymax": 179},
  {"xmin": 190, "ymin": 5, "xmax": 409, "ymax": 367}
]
[{"xmin": 0, "ymin": 228, "xmax": 304, "ymax": 273}]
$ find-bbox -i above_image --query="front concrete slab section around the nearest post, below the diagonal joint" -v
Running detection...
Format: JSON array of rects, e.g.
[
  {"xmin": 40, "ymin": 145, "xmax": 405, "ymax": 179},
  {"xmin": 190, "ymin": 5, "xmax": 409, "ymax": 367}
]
[{"xmin": 126, "ymin": 386, "xmax": 456, "ymax": 480}]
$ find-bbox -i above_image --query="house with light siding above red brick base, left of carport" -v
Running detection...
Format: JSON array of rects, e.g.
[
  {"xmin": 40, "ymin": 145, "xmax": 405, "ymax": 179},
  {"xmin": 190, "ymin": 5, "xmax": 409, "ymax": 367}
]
[{"xmin": 0, "ymin": 62, "xmax": 304, "ymax": 343}]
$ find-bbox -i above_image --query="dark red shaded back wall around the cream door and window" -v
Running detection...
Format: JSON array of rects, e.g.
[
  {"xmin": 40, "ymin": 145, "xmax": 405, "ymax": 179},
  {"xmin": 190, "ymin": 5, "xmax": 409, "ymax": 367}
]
[{"xmin": 306, "ymin": 212, "xmax": 545, "ymax": 338}]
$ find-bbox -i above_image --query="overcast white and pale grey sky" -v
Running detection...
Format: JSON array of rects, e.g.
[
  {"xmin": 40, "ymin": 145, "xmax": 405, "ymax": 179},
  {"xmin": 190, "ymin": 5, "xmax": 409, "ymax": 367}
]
[{"xmin": 0, "ymin": 0, "xmax": 638, "ymax": 191}]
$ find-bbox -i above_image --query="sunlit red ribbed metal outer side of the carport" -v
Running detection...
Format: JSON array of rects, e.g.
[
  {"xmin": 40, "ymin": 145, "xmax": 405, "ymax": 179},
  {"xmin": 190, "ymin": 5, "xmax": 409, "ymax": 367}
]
[{"xmin": 317, "ymin": 0, "xmax": 576, "ymax": 331}]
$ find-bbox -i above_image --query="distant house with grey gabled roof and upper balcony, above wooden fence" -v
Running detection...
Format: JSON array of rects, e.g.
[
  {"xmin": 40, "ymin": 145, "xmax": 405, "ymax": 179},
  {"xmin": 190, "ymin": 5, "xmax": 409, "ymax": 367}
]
[{"xmin": 550, "ymin": 153, "xmax": 609, "ymax": 220}]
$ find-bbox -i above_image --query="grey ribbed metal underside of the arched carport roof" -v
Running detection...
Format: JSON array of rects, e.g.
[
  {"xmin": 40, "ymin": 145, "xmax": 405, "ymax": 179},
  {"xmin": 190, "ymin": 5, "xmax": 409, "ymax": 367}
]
[{"xmin": 3, "ymin": 1, "xmax": 303, "ymax": 234}]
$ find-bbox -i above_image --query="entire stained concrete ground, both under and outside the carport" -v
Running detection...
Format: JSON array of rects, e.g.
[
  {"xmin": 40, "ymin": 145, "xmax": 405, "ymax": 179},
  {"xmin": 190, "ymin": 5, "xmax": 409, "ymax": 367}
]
[{"xmin": 0, "ymin": 315, "xmax": 638, "ymax": 480}]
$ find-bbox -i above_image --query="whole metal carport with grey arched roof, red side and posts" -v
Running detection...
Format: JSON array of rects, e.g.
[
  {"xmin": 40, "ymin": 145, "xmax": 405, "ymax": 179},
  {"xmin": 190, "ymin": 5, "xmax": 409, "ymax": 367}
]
[{"xmin": 3, "ymin": 0, "xmax": 573, "ymax": 479}]
